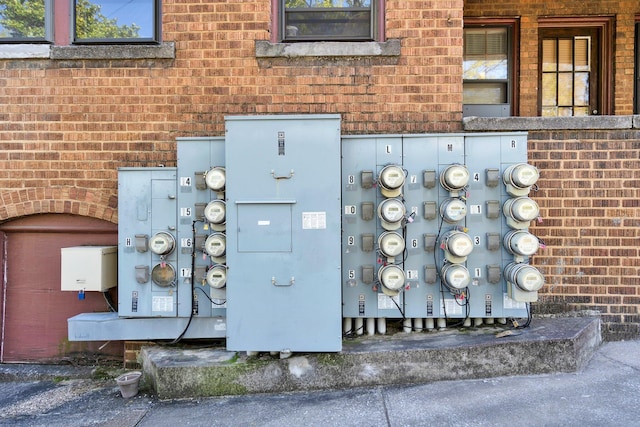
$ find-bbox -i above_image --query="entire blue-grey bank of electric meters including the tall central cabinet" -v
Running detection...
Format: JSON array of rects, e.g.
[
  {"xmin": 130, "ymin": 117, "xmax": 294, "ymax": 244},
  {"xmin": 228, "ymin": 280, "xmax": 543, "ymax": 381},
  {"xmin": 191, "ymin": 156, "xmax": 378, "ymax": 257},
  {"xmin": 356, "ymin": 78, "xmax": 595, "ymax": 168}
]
[{"xmin": 67, "ymin": 115, "xmax": 544, "ymax": 354}]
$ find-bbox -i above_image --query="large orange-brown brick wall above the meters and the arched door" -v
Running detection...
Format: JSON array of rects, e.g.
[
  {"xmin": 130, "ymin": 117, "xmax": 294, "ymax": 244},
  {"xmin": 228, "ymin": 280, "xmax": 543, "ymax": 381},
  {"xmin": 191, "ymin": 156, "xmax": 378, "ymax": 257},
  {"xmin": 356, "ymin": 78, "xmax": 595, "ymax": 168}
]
[{"xmin": 0, "ymin": 0, "xmax": 463, "ymax": 226}]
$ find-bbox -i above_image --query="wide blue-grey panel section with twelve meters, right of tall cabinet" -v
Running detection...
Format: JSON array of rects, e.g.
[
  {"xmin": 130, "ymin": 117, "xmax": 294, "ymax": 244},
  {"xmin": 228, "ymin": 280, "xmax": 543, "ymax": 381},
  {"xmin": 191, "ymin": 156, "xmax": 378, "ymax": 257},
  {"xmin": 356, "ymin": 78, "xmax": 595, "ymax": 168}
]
[{"xmin": 342, "ymin": 133, "xmax": 544, "ymax": 334}]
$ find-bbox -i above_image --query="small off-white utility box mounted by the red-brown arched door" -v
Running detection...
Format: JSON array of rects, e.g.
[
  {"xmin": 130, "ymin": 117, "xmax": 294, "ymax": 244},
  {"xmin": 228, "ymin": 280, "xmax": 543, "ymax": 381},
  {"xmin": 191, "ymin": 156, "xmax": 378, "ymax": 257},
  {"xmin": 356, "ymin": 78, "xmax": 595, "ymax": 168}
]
[{"xmin": 60, "ymin": 246, "xmax": 118, "ymax": 292}]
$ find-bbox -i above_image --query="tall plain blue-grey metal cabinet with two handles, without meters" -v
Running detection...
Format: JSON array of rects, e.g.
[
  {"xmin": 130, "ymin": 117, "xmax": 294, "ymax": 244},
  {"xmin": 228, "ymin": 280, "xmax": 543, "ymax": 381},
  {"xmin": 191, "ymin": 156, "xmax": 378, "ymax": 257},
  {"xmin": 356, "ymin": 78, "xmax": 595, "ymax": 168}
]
[{"xmin": 225, "ymin": 115, "xmax": 342, "ymax": 352}]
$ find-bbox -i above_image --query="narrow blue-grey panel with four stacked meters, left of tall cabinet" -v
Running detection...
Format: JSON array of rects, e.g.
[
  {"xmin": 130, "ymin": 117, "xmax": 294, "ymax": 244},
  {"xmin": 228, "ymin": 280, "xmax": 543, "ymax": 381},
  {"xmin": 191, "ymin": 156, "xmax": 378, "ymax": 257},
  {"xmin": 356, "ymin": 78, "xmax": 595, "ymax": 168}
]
[{"xmin": 177, "ymin": 137, "xmax": 227, "ymax": 317}]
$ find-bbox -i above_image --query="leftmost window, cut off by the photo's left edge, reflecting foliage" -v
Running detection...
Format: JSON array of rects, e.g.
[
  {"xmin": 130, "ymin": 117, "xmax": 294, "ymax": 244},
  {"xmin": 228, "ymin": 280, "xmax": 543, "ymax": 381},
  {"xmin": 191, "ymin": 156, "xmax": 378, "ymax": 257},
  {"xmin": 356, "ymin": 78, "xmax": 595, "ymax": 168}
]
[{"xmin": 0, "ymin": 0, "xmax": 53, "ymax": 43}]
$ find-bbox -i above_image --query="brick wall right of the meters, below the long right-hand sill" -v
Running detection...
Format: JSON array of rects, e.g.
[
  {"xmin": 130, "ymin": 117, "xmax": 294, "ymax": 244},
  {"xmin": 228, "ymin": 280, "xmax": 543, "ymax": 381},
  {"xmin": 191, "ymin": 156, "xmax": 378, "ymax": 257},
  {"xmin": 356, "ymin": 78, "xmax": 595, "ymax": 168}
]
[{"xmin": 529, "ymin": 129, "xmax": 640, "ymax": 339}]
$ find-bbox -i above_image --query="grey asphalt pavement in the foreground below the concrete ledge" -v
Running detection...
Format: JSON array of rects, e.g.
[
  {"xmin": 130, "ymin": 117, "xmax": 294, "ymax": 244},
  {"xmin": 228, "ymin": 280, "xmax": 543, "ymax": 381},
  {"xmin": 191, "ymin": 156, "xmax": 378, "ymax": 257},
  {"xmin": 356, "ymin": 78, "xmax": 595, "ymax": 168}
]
[{"xmin": 0, "ymin": 341, "xmax": 640, "ymax": 427}]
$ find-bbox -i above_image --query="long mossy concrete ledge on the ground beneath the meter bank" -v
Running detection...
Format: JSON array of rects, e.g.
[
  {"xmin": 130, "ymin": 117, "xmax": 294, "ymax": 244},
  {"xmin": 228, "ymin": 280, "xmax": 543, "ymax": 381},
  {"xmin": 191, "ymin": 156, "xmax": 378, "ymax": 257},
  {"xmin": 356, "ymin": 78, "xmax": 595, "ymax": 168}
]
[{"xmin": 141, "ymin": 318, "xmax": 601, "ymax": 399}]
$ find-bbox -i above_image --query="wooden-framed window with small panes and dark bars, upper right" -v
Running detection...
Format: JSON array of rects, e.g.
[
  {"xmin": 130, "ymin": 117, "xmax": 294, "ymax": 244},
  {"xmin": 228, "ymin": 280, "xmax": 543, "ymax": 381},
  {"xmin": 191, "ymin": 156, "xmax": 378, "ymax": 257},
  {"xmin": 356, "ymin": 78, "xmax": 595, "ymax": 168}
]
[{"xmin": 538, "ymin": 17, "xmax": 613, "ymax": 116}]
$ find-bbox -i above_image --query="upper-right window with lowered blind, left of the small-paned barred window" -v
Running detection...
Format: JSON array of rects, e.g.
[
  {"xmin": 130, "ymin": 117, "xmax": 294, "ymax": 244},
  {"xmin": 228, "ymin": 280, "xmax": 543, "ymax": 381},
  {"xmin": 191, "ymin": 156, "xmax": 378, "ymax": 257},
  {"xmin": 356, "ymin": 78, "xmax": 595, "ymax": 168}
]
[{"xmin": 463, "ymin": 18, "xmax": 516, "ymax": 116}]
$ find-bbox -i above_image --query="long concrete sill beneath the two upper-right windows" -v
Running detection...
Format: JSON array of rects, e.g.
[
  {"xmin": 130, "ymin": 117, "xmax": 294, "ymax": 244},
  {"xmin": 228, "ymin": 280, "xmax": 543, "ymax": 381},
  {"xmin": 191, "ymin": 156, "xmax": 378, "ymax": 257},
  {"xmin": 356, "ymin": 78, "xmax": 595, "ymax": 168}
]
[{"xmin": 462, "ymin": 116, "xmax": 640, "ymax": 132}]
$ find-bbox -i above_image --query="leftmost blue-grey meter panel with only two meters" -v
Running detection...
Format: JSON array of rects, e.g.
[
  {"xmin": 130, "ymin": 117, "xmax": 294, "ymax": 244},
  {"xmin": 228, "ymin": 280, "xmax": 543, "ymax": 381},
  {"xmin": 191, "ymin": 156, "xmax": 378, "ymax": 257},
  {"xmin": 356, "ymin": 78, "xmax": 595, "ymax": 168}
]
[{"xmin": 118, "ymin": 168, "xmax": 178, "ymax": 317}]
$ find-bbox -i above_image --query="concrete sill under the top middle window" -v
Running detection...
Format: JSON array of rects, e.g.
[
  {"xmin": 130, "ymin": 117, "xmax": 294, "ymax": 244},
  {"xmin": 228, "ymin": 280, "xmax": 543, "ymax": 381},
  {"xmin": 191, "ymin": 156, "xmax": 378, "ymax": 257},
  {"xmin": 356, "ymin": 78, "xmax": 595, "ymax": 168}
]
[{"xmin": 256, "ymin": 39, "xmax": 400, "ymax": 58}]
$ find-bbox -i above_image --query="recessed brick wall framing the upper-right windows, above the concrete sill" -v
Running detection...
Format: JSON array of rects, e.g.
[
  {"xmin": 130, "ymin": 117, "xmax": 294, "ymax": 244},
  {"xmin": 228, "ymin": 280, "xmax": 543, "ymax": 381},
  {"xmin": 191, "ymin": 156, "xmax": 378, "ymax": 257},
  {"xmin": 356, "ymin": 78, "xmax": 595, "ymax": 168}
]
[{"xmin": 464, "ymin": 0, "xmax": 640, "ymax": 116}]
